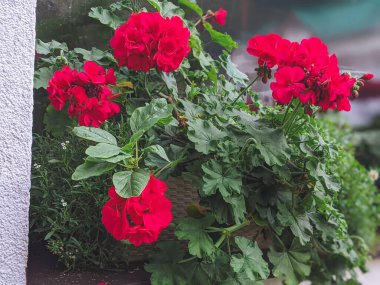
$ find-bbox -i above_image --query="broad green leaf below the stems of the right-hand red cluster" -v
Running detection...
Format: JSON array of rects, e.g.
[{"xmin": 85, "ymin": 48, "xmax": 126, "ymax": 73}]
[{"xmin": 248, "ymin": 124, "xmax": 290, "ymax": 166}]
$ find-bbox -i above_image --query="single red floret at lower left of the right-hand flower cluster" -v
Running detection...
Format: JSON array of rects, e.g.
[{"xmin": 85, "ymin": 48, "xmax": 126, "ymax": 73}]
[{"xmin": 270, "ymin": 66, "xmax": 305, "ymax": 104}]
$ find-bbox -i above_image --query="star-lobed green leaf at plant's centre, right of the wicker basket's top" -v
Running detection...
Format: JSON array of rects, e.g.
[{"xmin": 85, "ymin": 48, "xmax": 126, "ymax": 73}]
[{"xmin": 202, "ymin": 159, "xmax": 242, "ymax": 197}]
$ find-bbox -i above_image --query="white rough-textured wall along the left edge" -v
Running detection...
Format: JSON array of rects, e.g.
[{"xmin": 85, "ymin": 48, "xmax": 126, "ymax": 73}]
[{"xmin": 0, "ymin": 0, "xmax": 36, "ymax": 285}]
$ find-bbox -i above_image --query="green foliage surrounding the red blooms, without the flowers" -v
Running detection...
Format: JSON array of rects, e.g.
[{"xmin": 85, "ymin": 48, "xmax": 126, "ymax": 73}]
[{"xmin": 32, "ymin": 0, "xmax": 379, "ymax": 285}]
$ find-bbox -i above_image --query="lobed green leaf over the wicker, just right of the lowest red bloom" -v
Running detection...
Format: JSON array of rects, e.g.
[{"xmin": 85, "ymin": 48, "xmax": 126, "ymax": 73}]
[{"xmin": 175, "ymin": 215, "xmax": 214, "ymax": 258}]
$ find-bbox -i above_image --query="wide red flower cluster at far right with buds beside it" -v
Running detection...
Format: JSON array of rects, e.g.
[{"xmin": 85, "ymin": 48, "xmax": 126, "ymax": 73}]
[{"xmin": 247, "ymin": 34, "xmax": 362, "ymax": 111}]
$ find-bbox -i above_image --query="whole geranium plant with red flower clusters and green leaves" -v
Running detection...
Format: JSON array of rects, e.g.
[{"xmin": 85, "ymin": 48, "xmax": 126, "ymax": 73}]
[{"xmin": 32, "ymin": 0, "xmax": 378, "ymax": 285}]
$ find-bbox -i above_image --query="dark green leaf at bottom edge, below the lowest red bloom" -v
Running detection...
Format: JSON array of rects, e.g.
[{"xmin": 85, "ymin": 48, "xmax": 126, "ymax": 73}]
[{"xmin": 144, "ymin": 242, "xmax": 188, "ymax": 285}]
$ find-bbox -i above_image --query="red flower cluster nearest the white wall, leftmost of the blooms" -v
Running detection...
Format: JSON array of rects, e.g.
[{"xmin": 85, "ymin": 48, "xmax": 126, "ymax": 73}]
[{"xmin": 47, "ymin": 61, "xmax": 120, "ymax": 127}]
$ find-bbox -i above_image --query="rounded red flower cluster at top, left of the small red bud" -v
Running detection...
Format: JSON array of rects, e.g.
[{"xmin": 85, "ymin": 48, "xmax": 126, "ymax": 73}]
[{"xmin": 110, "ymin": 12, "xmax": 190, "ymax": 72}]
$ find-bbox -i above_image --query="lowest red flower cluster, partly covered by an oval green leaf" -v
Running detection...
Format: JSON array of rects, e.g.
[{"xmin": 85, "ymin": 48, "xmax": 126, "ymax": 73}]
[{"xmin": 102, "ymin": 175, "xmax": 173, "ymax": 246}]
